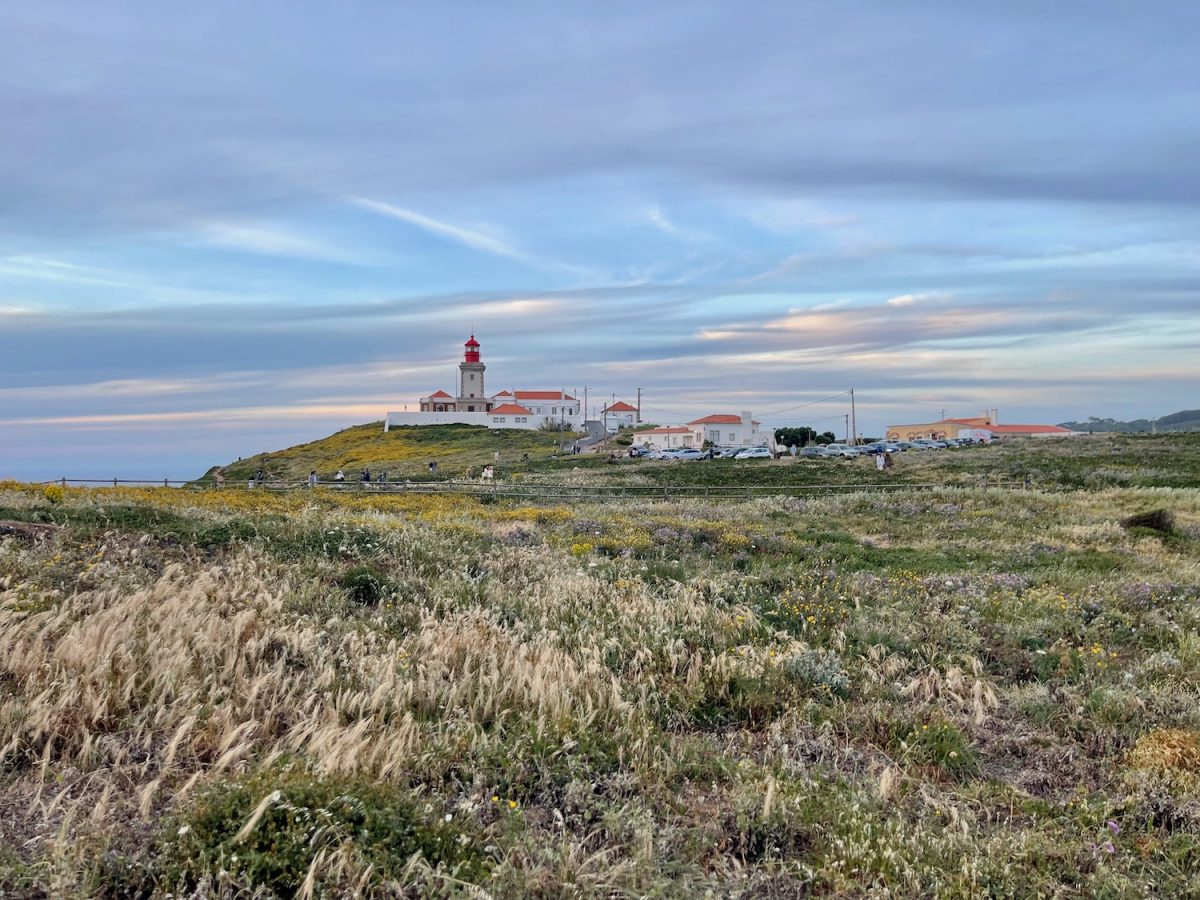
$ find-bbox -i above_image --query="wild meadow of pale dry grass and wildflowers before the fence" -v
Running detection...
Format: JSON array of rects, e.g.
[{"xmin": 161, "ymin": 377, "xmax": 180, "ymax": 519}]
[{"xmin": 0, "ymin": 475, "xmax": 1200, "ymax": 898}]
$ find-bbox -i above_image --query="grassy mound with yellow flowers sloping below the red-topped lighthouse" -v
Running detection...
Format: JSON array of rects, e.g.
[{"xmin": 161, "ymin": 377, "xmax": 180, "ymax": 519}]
[{"xmin": 200, "ymin": 421, "xmax": 574, "ymax": 481}]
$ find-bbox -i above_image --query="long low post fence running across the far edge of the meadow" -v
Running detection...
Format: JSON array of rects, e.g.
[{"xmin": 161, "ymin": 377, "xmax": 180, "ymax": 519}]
[{"xmin": 43, "ymin": 473, "xmax": 1032, "ymax": 502}]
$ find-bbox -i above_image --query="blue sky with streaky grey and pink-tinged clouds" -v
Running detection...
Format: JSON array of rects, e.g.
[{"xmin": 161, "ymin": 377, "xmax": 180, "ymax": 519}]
[{"xmin": 0, "ymin": 0, "xmax": 1200, "ymax": 478}]
